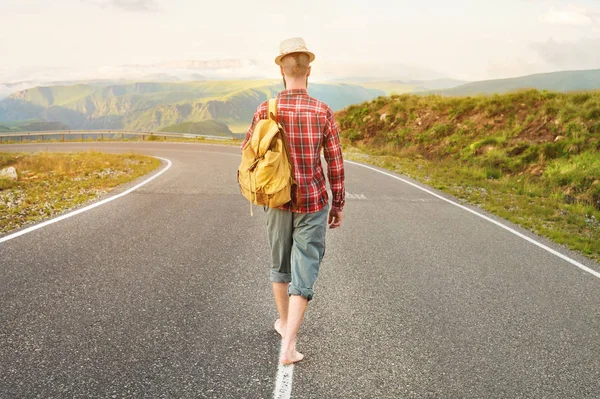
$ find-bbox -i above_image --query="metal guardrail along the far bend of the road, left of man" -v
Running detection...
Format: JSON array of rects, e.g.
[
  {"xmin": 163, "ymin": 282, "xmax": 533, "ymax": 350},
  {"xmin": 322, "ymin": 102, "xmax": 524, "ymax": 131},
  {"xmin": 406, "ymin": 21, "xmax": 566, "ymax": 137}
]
[{"xmin": 0, "ymin": 130, "xmax": 235, "ymax": 144}]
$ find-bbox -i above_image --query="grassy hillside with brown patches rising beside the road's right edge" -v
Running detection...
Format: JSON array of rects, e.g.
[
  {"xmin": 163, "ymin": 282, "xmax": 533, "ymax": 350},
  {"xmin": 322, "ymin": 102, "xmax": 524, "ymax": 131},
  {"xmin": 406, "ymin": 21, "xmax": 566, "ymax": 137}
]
[{"xmin": 338, "ymin": 91, "xmax": 600, "ymax": 259}]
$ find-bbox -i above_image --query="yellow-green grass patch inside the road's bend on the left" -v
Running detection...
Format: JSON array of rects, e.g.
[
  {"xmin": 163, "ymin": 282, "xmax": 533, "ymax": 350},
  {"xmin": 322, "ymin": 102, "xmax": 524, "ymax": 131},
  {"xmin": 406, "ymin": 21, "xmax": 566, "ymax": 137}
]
[{"xmin": 0, "ymin": 152, "xmax": 160, "ymax": 233}]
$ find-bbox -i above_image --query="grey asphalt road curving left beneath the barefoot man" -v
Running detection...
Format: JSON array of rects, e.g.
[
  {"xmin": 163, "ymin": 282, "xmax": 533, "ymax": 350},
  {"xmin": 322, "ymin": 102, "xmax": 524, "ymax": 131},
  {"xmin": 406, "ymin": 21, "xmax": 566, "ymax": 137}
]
[{"xmin": 0, "ymin": 143, "xmax": 600, "ymax": 398}]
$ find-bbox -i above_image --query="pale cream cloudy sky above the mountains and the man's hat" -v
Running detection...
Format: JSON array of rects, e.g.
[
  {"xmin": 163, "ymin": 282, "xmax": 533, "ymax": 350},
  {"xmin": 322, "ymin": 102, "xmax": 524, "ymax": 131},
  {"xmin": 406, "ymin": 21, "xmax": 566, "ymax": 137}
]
[{"xmin": 0, "ymin": 0, "xmax": 600, "ymax": 82}]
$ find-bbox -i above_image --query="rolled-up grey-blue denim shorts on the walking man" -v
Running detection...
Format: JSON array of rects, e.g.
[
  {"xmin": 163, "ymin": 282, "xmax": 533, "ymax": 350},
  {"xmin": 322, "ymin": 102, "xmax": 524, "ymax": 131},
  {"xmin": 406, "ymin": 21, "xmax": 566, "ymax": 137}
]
[{"xmin": 267, "ymin": 205, "xmax": 329, "ymax": 301}]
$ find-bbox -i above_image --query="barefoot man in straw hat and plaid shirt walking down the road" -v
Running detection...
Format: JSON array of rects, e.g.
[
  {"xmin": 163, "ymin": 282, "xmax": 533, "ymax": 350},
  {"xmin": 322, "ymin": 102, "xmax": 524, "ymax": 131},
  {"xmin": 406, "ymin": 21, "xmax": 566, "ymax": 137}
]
[{"xmin": 242, "ymin": 38, "xmax": 345, "ymax": 365}]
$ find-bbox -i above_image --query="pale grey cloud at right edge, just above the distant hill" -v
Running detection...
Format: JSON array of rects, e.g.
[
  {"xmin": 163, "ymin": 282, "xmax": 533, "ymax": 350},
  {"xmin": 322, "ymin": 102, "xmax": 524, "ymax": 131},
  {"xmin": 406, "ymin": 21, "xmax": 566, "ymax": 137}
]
[{"xmin": 531, "ymin": 38, "xmax": 600, "ymax": 70}]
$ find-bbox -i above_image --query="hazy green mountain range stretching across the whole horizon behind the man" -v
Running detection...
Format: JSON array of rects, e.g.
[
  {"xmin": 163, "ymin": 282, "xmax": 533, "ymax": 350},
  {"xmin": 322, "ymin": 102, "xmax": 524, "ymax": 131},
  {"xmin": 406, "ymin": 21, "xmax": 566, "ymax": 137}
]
[{"xmin": 0, "ymin": 68, "xmax": 600, "ymax": 135}]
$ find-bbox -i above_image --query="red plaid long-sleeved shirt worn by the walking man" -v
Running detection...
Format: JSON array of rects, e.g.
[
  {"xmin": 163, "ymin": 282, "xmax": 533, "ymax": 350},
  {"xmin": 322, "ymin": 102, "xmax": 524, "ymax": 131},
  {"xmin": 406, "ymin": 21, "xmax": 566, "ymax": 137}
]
[{"xmin": 242, "ymin": 89, "xmax": 346, "ymax": 213}]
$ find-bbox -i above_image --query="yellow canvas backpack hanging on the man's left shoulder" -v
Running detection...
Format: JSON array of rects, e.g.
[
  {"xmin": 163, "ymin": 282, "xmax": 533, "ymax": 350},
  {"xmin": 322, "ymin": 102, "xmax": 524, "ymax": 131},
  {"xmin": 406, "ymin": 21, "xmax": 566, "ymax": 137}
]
[{"xmin": 238, "ymin": 99, "xmax": 299, "ymax": 215}]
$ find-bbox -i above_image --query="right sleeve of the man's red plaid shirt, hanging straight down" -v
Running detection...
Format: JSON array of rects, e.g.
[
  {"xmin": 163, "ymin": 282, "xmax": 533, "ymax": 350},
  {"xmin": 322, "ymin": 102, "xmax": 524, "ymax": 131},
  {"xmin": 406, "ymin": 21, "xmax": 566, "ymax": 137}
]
[{"xmin": 323, "ymin": 109, "xmax": 346, "ymax": 211}]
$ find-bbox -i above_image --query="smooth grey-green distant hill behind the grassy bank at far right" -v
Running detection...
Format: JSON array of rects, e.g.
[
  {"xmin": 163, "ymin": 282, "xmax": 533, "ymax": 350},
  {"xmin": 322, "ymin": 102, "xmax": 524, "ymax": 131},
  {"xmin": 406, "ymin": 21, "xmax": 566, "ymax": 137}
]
[{"xmin": 425, "ymin": 69, "xmax": 600, "ymax": 96}]
